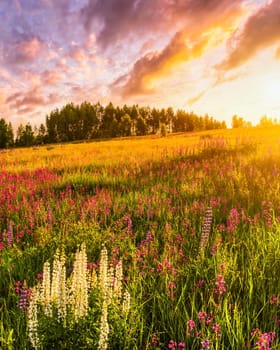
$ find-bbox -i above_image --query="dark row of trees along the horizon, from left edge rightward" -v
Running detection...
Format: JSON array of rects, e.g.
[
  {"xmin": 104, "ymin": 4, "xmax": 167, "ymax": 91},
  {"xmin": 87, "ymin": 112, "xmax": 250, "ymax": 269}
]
[{"xmin": 0, "ymin": 102, "xmax": 226, "ymax": 148}]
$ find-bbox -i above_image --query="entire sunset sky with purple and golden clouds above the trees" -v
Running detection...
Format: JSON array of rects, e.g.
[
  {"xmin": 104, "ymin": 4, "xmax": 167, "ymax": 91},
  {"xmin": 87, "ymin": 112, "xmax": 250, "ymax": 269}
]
[{"xmin": 0, "ymin": 0, "xmax": 280, "ymax": 126}]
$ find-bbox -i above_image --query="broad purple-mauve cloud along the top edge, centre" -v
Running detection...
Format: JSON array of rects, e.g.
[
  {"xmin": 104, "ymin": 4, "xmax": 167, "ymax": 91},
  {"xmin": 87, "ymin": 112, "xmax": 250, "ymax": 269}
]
[{"xmin": 81, "ymin": 0, "xmax": 243, "ymax": 49}]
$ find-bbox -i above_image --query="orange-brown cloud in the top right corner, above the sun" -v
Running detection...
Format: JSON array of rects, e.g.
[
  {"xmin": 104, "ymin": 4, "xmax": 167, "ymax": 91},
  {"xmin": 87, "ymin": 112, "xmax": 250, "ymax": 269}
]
[{"xmin": 217, "ymin": 0, "xmax": 280, "ymax": 70}]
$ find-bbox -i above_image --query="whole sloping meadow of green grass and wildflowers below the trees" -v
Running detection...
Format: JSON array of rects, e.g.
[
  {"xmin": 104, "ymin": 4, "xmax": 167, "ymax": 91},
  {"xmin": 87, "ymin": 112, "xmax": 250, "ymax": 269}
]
[{"xmin": 0, "ymin": 127, "xmax": 280, "ymax": 350}]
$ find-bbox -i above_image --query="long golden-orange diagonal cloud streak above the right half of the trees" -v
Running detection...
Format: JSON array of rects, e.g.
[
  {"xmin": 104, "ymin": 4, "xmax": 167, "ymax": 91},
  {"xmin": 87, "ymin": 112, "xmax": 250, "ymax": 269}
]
[{"xmin": 111, "ymin": 0, "xmax": 245, "ymax": 97}]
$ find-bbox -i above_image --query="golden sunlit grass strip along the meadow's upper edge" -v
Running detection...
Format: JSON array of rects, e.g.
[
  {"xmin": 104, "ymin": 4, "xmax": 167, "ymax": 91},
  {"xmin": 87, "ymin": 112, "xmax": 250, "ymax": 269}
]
[{"xmin": 0, "ymin": 126, "xmax": 280, "ymax": 172}]
